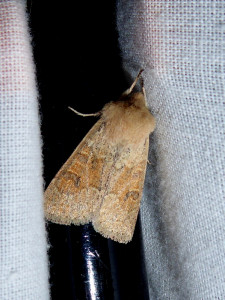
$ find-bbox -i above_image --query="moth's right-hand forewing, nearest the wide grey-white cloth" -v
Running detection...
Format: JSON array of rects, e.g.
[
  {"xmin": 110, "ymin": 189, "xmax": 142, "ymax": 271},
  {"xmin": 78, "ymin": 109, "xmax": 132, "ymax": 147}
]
[{"xmin": 92, "ymin": 138, "xmax": 149, "ymax": 243}]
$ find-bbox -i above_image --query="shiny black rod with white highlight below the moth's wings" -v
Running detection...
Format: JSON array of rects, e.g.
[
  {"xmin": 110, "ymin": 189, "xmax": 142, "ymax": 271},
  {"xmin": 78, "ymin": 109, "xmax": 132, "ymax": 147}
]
[{"xmin": 67, "ymin": 224, "xmax": 114, "ymax": 300}]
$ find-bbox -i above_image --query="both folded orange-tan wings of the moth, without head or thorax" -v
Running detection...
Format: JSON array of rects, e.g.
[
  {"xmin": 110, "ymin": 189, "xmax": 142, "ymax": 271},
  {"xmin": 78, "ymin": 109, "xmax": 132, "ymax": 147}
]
[{"xmin": 44, "ymin": 119, "xmax": 149, "ymax": 243}]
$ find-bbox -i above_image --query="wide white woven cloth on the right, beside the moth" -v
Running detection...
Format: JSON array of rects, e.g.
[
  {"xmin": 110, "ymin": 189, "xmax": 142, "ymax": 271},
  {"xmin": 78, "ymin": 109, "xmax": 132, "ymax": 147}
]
[{"xmin": 117, "ymin": 0, "xmax": 225, "ymax": 300}]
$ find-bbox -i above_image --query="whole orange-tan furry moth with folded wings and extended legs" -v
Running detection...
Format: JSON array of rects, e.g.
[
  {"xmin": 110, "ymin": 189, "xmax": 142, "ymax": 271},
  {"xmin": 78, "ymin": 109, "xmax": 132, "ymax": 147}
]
[{"xmin": 44, "ymin": 70, "xmax": 155, "ymax": 243}]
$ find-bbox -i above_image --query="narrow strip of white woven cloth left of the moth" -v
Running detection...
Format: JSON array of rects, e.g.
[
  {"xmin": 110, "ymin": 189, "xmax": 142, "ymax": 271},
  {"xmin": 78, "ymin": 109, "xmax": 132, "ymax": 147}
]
[{"xmin": 0, "ymin": 1, "xmax": 49, "ymax": 300}]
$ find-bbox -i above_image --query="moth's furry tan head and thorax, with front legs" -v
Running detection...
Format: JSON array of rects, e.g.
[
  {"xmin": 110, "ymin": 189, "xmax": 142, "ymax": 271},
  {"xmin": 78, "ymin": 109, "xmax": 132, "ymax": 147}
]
[{"xmin": 102, "ymin": 70, "xmax": 155, "ymax": 145}]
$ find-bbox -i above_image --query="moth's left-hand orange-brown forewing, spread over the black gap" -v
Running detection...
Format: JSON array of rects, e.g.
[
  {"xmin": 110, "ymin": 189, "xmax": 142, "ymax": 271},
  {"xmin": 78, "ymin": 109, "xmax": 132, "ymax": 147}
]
[{"xmin": 44, "ymin": 119, "xmax": 107, "ymax": 225}]
